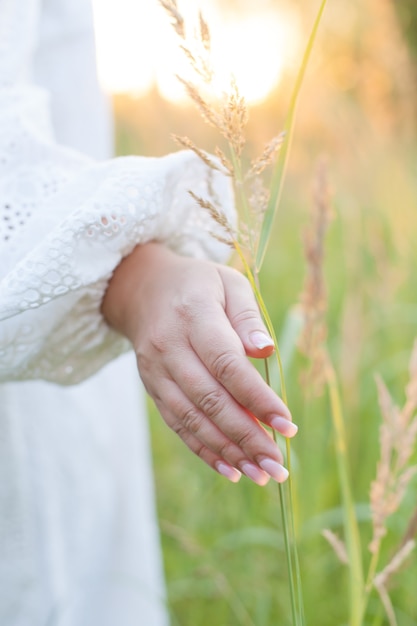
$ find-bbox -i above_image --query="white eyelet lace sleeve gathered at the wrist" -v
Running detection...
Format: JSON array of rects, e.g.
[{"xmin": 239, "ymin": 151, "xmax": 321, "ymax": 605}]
[{"xmin": 0, "ymin": 0, "xmax": 233, "ymax": 384}]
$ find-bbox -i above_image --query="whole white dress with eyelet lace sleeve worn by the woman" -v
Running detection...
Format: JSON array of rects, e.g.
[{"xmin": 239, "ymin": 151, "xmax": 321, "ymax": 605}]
[{"xmin": 0, "ymin": 0, "xmax": 232, "ymax": 626}]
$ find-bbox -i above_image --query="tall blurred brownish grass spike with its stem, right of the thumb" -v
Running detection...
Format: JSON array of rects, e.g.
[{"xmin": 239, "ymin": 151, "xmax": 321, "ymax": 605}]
[{"xmin": 298, "ymin": 160, "xmax": 364, "ymax": 626}]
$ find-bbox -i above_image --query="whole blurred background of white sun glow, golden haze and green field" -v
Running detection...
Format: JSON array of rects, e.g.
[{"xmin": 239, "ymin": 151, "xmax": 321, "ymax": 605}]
[{"xmin": 95, "ymin": 0, "xmax": 417, "ymax": 626}]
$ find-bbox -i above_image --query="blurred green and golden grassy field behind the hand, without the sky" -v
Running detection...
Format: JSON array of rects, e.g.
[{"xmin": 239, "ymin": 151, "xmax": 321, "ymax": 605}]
[{"xmin": 115, "ymin": 3, "xmax": 417, "ymax": 626}]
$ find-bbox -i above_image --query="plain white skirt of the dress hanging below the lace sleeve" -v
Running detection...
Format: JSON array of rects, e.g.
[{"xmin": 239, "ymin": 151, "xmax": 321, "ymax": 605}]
[{"xmin": 0, "ymin": 353, "xmax": 168, "ymax": 626}]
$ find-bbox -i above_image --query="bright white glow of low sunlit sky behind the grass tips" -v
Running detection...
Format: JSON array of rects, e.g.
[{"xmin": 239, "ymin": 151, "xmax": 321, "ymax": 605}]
[{"xmin": 94, "ymin": 0, "xmax": 300, "ymax": 102}]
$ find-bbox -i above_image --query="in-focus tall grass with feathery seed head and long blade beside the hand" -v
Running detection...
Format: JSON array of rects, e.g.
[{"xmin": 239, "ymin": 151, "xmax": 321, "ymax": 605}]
[{"xmin": 160, "ymin": 0, "xmax": 326, "ymax": 626}]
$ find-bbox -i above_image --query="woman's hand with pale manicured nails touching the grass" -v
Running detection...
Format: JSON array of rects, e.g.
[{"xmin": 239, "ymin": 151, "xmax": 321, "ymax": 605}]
[{"xmin": 103, "ymin": 243, "xmax": 297, "ymax": 485}]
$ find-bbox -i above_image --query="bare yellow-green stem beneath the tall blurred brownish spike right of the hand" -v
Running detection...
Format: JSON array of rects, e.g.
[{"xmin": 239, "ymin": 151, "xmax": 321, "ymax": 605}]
[{"xmin": 326, "ymin": 357, "xmax": 364, "ymax": 626}]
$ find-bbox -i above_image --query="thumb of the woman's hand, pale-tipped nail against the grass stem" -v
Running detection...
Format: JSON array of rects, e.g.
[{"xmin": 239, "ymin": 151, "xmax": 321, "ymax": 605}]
[{"xmin": 220, "ymin": 268, "xmax": 274, "ymax": 359}]
